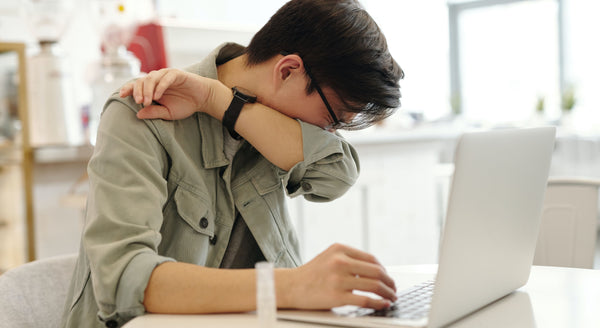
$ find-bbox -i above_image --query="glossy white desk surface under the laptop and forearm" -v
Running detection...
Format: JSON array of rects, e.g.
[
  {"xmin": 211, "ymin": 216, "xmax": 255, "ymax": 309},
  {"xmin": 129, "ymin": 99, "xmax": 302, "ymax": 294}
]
[{"xmin": 125, "ymin": 265, "xmax": 600, "ymax": 328}]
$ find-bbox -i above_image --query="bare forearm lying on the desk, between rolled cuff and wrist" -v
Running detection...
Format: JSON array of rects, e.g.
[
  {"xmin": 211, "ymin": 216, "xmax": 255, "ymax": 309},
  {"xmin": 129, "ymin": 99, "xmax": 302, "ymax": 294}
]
[{"xmin": 144, "ymin": 262, "xmax": 293, "ymax": 313}]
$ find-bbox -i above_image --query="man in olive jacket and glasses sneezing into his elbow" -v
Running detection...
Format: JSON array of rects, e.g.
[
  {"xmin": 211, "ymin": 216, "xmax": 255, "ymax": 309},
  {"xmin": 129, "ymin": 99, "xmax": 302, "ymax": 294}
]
[{"xmin": 64, "ymin": 0, "xmax": 402, "ymax": 327}]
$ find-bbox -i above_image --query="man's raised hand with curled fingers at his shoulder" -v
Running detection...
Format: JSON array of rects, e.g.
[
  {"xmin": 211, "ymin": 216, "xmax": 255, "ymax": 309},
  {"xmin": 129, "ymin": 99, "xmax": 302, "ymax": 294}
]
[{"xmin": 119, "ymin": 68, "xmax": 218, "ymax": 120}]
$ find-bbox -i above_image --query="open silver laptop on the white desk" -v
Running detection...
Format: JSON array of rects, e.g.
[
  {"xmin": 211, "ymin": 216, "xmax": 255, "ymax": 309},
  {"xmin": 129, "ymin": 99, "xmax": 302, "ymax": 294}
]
[{"xmin": 278, "ymin": 127, "xmax": 556, "ymax": 328}]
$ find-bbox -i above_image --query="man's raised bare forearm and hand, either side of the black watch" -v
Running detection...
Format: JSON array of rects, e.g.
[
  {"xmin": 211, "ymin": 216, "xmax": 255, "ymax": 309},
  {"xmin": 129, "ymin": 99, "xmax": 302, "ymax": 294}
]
[{"xmin": 125, "ymin": 69, "xmax": 304, "ymax": 171}]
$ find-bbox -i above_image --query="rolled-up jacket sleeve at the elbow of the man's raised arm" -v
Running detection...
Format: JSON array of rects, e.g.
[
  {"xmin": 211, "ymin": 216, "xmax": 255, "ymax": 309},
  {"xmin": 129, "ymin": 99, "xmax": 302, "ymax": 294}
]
[{"xmin": 279, "ymin": 121, "xmax": 360, "ymax": 202}]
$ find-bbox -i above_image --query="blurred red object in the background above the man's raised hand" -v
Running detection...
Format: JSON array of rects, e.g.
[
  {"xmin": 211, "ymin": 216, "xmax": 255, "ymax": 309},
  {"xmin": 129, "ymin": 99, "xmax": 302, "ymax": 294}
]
[{"xmin": 127, "ymin": 23, "xmax": 167, "ymax": 73}]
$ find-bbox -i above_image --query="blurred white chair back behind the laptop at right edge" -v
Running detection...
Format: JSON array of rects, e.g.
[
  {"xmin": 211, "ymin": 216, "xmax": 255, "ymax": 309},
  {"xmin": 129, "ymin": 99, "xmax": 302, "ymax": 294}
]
[{"xmin": 533, "ymin": 177, "xmax": 600, "ymax": 269}]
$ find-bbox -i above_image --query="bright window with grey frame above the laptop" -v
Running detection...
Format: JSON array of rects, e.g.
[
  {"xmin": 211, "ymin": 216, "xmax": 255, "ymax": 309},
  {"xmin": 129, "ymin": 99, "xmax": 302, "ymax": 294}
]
[{"xmin": 448, "ymin": 0, "xmax": 562, "ymax": 124}]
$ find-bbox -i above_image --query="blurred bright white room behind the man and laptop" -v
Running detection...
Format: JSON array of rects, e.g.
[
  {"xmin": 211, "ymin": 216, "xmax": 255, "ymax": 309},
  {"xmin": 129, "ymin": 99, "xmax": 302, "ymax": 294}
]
[{"xmin": 0, "ymin": 0, "xmax": 600, "ymax": 270}]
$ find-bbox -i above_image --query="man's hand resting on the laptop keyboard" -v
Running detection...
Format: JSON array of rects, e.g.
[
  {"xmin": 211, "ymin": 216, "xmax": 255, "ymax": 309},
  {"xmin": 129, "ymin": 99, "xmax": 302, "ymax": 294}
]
[{"xmin": 283, "ymin": 244, "xmax": 396, "ymax": 309}]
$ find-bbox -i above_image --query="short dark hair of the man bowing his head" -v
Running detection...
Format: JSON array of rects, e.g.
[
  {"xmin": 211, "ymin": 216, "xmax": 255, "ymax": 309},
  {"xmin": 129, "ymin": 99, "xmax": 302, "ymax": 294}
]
[{"xmin": 246, "ymin": 0, "xmax": 404, "ymax": 129}]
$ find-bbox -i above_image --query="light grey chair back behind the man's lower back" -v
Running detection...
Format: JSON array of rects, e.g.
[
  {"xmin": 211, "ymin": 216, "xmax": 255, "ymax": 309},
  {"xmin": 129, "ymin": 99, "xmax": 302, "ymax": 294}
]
[{"xmin": 0, "ymin": 254, "xmax": 77, "ymax": 328}]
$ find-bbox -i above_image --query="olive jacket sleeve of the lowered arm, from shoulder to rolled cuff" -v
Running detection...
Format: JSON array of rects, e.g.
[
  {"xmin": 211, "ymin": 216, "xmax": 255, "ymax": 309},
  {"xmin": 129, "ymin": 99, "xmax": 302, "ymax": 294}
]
[{"xmin": 82, "ymin": 98, "xmax": 173, "ymax": 323}]
